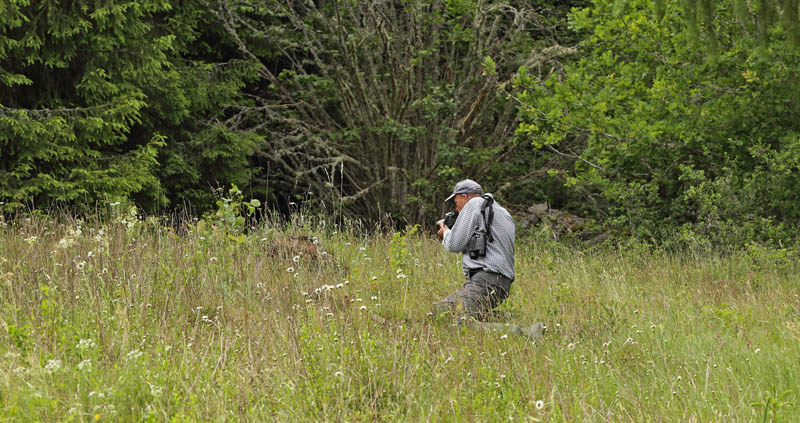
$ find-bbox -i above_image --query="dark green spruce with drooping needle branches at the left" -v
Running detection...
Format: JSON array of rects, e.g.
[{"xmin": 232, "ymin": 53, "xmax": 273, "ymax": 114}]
[{"xmin": 0, "ymin": 0, "xmax": 260, "ymax": 209}]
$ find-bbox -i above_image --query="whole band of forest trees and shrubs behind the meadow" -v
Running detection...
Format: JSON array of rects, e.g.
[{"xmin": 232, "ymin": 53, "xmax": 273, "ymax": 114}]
[{"xmin": 0, "ymin": 0, "xmax": 800, "ymax": 249}]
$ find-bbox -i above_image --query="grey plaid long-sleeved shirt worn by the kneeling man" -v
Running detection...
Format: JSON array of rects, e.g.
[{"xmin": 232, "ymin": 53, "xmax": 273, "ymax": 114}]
[{"xmin": 442, "ymin": 194, "xmax": 516, "ymax": 281}]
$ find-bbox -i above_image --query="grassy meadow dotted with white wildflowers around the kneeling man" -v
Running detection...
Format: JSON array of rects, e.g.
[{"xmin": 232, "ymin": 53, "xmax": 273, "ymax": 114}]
[{"xmin": 0, "ymin": 213, "xmax": 800, "ymax": 422}]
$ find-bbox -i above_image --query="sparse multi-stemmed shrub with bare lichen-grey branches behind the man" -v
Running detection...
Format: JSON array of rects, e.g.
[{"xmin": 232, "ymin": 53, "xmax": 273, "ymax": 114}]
[{"xmin": 206, "ymin": 0, "xmax": 558, "ymax": 223}]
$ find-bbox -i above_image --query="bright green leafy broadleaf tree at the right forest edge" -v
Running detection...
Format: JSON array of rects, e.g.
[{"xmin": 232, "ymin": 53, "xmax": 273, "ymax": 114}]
[{"xmin": 516, "ymin": 1, "xmax": 800, "ymax": 245}]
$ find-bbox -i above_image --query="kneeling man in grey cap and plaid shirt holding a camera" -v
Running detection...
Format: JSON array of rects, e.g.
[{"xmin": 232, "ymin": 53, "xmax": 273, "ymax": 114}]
[{"xmin": 435, "ymin": 179, "xmax": 544, "ymax": 338}]
